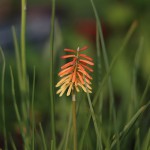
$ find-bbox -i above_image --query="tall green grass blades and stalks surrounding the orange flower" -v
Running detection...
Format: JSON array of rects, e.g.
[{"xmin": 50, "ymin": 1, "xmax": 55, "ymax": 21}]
[{"xmin": 0, "ymin": 0, "xmax": 150, "ymax": 150}]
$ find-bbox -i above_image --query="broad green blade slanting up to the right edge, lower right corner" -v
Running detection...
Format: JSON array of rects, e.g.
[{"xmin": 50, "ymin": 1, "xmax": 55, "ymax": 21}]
[{"xmin": 111, "ymin": 102, "xmax": 150, "ymax": 149}]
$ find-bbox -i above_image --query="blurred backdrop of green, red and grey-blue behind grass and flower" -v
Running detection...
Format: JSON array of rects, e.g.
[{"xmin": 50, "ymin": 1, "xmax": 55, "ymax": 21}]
[{"xmin": 0, "ymin": 0, "xmax": 150, "ymax": 147}]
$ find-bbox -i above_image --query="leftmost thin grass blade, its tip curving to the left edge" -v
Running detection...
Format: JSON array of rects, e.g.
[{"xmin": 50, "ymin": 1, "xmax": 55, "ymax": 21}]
[{"xmin": 0, "ymin": 47, "xmax": 8, "ymax": 150}]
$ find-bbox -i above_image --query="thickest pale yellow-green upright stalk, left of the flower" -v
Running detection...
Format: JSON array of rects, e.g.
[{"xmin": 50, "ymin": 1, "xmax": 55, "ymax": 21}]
[{"xmin": 20, "ymin": 0, "xmax": 30, "ymax": 149}]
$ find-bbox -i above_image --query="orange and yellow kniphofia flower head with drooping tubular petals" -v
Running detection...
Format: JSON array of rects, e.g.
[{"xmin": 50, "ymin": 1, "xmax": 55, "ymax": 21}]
[{"xmin": 56, "ymin": 46, "xmax": 94, "ymax": 96}]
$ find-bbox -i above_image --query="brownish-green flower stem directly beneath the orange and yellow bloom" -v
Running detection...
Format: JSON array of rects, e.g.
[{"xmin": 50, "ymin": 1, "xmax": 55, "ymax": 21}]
[{"xmin": 72, "ymin": 92, "xmax": 77, "ymax": 150}]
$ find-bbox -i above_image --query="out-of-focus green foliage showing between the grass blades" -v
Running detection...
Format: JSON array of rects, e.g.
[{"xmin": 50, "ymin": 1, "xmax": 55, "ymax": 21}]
[{"xmin": 0, "ymin": 0, "xmax": 150, "ymax": 150}]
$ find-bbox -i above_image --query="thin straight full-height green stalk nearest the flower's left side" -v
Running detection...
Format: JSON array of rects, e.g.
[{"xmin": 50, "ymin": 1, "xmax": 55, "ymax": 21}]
[{"xmin": 50, "ymin": 0, "xmax": 56, "ymax": 150}]
